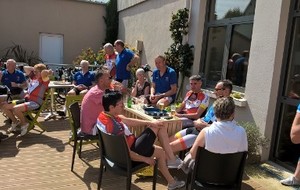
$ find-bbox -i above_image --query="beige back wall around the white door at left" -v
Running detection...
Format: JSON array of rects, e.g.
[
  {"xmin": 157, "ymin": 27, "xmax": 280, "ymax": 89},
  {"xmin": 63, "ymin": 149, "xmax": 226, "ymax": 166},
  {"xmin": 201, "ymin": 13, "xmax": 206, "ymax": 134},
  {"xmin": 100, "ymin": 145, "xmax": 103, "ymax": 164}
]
[{"xmin": 0, "ymin": 0, "xmax": 106, "ymax": 63}]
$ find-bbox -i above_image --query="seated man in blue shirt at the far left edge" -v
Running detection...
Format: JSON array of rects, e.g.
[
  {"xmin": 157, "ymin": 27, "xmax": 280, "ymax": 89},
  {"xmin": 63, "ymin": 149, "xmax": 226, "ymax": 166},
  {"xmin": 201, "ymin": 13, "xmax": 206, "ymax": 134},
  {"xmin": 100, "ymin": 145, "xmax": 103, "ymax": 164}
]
[{"xmin": 0, "ymin": 59, "xmax": 27, "ymax": 96}]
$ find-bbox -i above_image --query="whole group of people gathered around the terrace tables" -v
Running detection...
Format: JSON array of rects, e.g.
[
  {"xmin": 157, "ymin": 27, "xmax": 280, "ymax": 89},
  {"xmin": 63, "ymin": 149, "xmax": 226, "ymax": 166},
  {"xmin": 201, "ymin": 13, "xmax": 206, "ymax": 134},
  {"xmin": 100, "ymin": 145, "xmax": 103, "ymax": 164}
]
[{"xmin": 0, "ymin": 40, "xmax": 248, "ymax": 189}]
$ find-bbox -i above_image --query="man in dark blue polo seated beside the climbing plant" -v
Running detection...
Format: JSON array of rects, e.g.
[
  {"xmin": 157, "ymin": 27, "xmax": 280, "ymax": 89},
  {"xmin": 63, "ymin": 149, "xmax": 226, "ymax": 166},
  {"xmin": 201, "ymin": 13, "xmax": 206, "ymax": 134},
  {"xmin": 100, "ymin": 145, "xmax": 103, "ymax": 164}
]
[{"xmin": 150, "ymin": 55, "xmax": 177, "ymax": 106}]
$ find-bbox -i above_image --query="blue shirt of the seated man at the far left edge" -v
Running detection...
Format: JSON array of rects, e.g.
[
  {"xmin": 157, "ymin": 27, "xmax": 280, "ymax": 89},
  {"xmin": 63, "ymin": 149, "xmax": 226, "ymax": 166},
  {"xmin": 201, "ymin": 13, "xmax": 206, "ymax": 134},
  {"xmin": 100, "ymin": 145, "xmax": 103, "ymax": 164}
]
[{"xmin": 1, "ymin": 70, "xmax": 26, "ymax": 90}]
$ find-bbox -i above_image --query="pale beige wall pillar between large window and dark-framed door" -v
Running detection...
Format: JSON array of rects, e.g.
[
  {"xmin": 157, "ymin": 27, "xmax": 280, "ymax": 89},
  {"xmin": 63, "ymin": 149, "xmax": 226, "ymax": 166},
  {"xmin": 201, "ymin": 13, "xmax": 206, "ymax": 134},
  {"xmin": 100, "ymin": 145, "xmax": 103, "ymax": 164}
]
[{"xmin": 245, "ymin": 0, "xmax": 289, "ymax": 159}]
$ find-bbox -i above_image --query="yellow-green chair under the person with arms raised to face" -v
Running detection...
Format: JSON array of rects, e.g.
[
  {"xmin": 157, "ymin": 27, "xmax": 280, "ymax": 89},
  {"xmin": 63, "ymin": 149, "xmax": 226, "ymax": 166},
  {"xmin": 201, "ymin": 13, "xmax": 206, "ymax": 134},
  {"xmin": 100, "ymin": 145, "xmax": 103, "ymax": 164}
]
[{"xmin": 24, "ymin": 91, "xmax": 50, "ymax": 133}]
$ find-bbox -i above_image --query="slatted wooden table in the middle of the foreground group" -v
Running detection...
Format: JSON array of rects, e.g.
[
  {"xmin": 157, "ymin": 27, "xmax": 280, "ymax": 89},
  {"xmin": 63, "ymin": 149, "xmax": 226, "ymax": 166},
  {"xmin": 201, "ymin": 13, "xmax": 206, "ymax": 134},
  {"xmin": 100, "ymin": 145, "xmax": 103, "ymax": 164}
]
[{"xmin": 124, "ymin": 105, "xmax": 182, "ymax": 136}]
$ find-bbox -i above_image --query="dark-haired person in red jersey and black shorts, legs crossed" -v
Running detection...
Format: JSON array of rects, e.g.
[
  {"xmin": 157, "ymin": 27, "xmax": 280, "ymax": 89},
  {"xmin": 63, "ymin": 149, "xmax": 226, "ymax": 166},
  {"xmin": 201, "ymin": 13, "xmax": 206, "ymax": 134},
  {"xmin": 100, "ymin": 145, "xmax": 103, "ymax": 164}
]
[{"xmin": 97, "ymin": 90, "xmax": 185, "ymax": 189}]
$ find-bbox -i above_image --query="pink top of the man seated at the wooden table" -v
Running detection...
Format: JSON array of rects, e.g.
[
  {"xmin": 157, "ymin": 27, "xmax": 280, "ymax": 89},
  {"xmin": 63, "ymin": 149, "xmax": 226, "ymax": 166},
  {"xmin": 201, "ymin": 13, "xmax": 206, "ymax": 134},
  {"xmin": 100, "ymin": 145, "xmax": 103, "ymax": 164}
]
[{"xmin": 80, "ymin": 85, "xmax": 104, "ymax": 135}]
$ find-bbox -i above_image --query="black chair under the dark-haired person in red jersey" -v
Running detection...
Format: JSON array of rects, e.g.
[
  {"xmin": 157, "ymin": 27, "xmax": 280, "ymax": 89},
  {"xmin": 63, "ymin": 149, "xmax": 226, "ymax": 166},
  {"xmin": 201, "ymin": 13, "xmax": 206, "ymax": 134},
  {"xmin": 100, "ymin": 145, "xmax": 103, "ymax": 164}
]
[{"xmin": 98, "ymin": 130, "xmax": 157, "ymax": 190}]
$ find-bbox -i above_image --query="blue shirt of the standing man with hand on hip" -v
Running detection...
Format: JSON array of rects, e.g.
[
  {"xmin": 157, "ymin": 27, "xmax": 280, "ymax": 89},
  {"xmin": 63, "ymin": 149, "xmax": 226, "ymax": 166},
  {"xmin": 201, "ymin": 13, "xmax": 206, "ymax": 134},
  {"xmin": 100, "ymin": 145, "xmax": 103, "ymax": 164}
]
[{"xmin": 116, "ymin": 48, "xmax": 134, "ymax": 80}]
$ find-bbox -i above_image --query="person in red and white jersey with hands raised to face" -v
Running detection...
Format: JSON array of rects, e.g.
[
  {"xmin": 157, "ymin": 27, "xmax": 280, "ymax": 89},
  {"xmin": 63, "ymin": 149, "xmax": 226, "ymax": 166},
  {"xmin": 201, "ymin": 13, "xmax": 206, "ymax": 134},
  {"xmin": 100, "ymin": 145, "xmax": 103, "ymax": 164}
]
[{"xmin": 1, "ymin": 63, "xmax": 53, "ymax": 136}]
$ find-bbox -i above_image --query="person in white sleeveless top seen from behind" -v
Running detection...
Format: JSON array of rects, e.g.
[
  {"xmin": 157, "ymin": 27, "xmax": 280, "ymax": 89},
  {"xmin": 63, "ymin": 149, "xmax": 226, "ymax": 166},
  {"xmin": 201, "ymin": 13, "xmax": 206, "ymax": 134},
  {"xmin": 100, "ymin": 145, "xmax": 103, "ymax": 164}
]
[{"xmin": 182, "ymin": 97, "xmax": 248, "ymax": 173}]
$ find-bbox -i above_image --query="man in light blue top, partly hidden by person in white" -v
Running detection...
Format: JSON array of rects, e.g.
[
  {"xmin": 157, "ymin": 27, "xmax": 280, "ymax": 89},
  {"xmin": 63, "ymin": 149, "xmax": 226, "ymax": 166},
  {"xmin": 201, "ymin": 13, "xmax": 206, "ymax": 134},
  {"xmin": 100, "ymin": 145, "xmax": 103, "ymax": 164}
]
[{"xmin": 169, "ymin": 80, "xmax": 232, "ymax": 152}]
